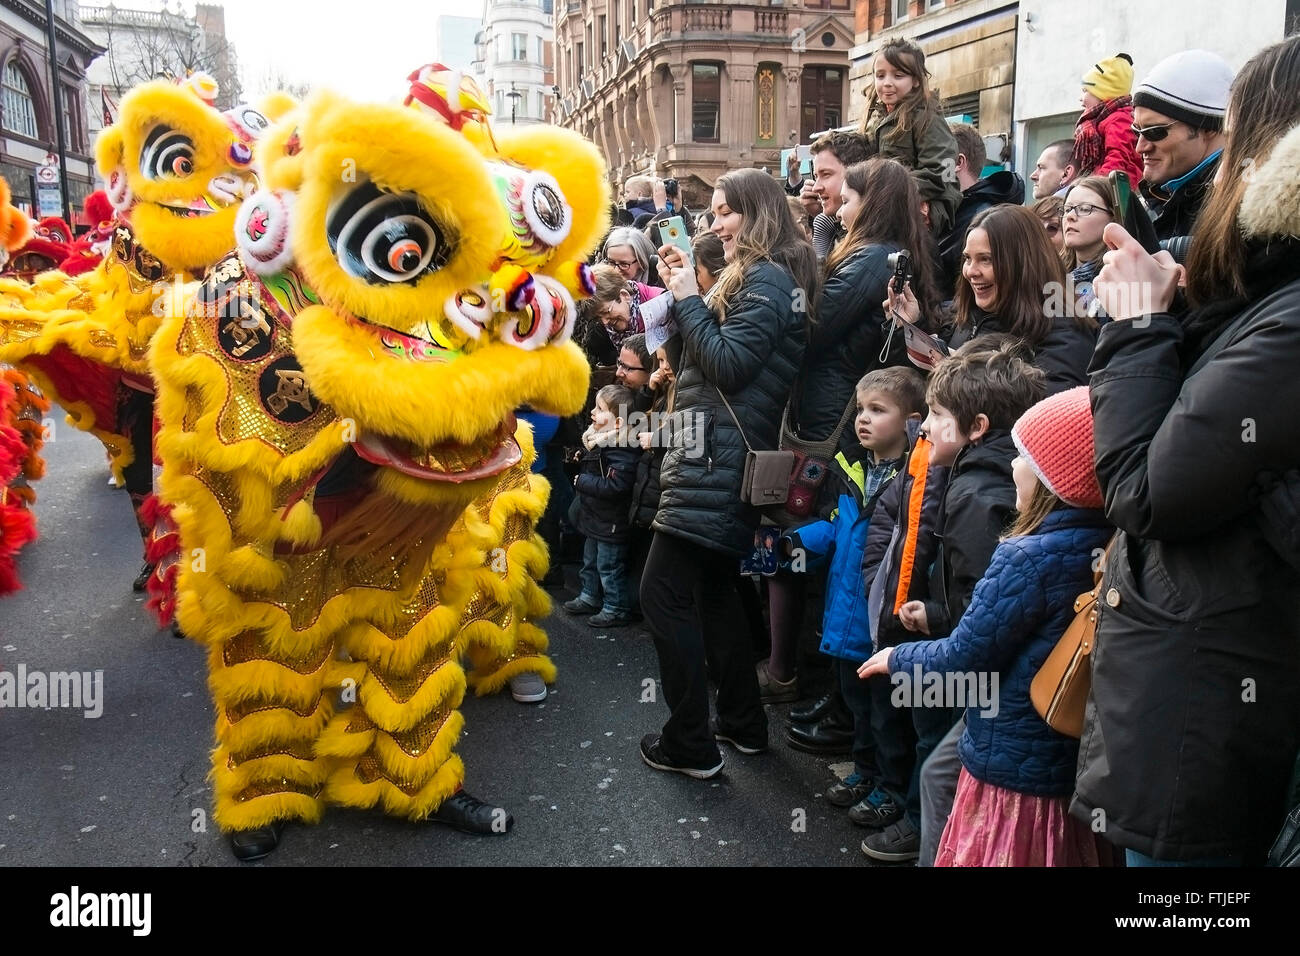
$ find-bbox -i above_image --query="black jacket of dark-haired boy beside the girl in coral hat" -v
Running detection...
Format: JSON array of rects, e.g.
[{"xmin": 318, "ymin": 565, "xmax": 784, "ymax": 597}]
[{"xmin": 926, "ymin": 429, "xmax": 1018, "ymax": 637}]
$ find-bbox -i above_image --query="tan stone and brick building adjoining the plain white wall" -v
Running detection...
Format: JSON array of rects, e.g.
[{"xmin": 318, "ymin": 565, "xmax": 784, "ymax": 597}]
[{"xmin": 849, "ymin": 0, "xmax": 1019, "ymax": 164}]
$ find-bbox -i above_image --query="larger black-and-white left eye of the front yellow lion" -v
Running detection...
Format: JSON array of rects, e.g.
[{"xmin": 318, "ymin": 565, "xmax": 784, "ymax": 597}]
[{"xmin": 325, "ymin": 182, "xmax": 451, "ymax": 285}]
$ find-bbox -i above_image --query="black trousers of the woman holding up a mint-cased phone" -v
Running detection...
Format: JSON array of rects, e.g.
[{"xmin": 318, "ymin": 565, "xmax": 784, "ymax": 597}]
[{"xmin": 641, "ymin": 531, "xmax": 767, "ymax": 766}]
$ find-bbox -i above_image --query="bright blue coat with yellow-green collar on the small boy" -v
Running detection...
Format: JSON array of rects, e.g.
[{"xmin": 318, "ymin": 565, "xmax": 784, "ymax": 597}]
[{"xmin": 787, "ymin": 449, "xmax": 904, "ymax": 663}]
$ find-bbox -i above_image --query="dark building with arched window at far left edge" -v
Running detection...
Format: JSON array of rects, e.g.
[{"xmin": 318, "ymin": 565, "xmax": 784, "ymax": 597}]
[{"xmin": 0, "ymin": 0, "xmax": 104, "ymax": 215}]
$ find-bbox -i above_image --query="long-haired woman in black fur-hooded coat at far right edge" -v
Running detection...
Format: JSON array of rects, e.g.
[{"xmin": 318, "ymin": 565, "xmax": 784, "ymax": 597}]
[{"xmin": 1071, "ymin": 36, "xmax": 1300, "ymax": 866}]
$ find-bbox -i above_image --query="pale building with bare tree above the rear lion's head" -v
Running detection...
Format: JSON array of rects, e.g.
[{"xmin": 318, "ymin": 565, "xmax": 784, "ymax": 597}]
[{"xmin": 81, "ymin": 4, "xmax": 243, "ymax": 151}]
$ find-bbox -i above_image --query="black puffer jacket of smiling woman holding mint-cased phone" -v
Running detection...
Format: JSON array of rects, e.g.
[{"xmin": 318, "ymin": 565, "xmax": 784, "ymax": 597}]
[{"xmin": 654, "ymin": 261, "xmax": 805, "ymax": 557}]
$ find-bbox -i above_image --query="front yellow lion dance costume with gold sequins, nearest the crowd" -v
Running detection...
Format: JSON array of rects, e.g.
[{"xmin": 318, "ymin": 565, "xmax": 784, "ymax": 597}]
[{"xmin": 151, "ymin": 69, "xmax": 607, "ymax": 858}]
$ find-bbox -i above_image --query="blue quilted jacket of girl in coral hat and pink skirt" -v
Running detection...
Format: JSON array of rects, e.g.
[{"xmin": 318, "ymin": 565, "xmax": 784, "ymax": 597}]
[{"xmin": 889, "ymin": 507, "xmax": 1112, "ymax": 796}]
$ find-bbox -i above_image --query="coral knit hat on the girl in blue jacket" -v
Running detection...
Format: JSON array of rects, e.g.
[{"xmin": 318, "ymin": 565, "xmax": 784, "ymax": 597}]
[{"xmin": 1011, "ymin": 385, "xmax": 1104, "ymax": 509}]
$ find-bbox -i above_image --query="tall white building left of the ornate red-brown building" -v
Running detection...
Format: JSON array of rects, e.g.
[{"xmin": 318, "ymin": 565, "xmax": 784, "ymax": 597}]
[{"xmin": 478, "ymin": 0, "xmax": 555, "ymax": 126}]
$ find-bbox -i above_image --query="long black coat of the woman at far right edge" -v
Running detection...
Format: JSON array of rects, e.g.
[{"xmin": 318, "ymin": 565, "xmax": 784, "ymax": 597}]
[{"xmin": 1071, "ymin": 274, "xmax": 1300, "ymax": 862}]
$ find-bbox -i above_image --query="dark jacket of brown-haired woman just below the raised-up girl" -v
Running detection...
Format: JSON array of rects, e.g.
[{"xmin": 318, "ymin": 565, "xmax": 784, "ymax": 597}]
[{"xmin": 792, "ymin": 243, "xmax": 901, "ymax": 450}]
